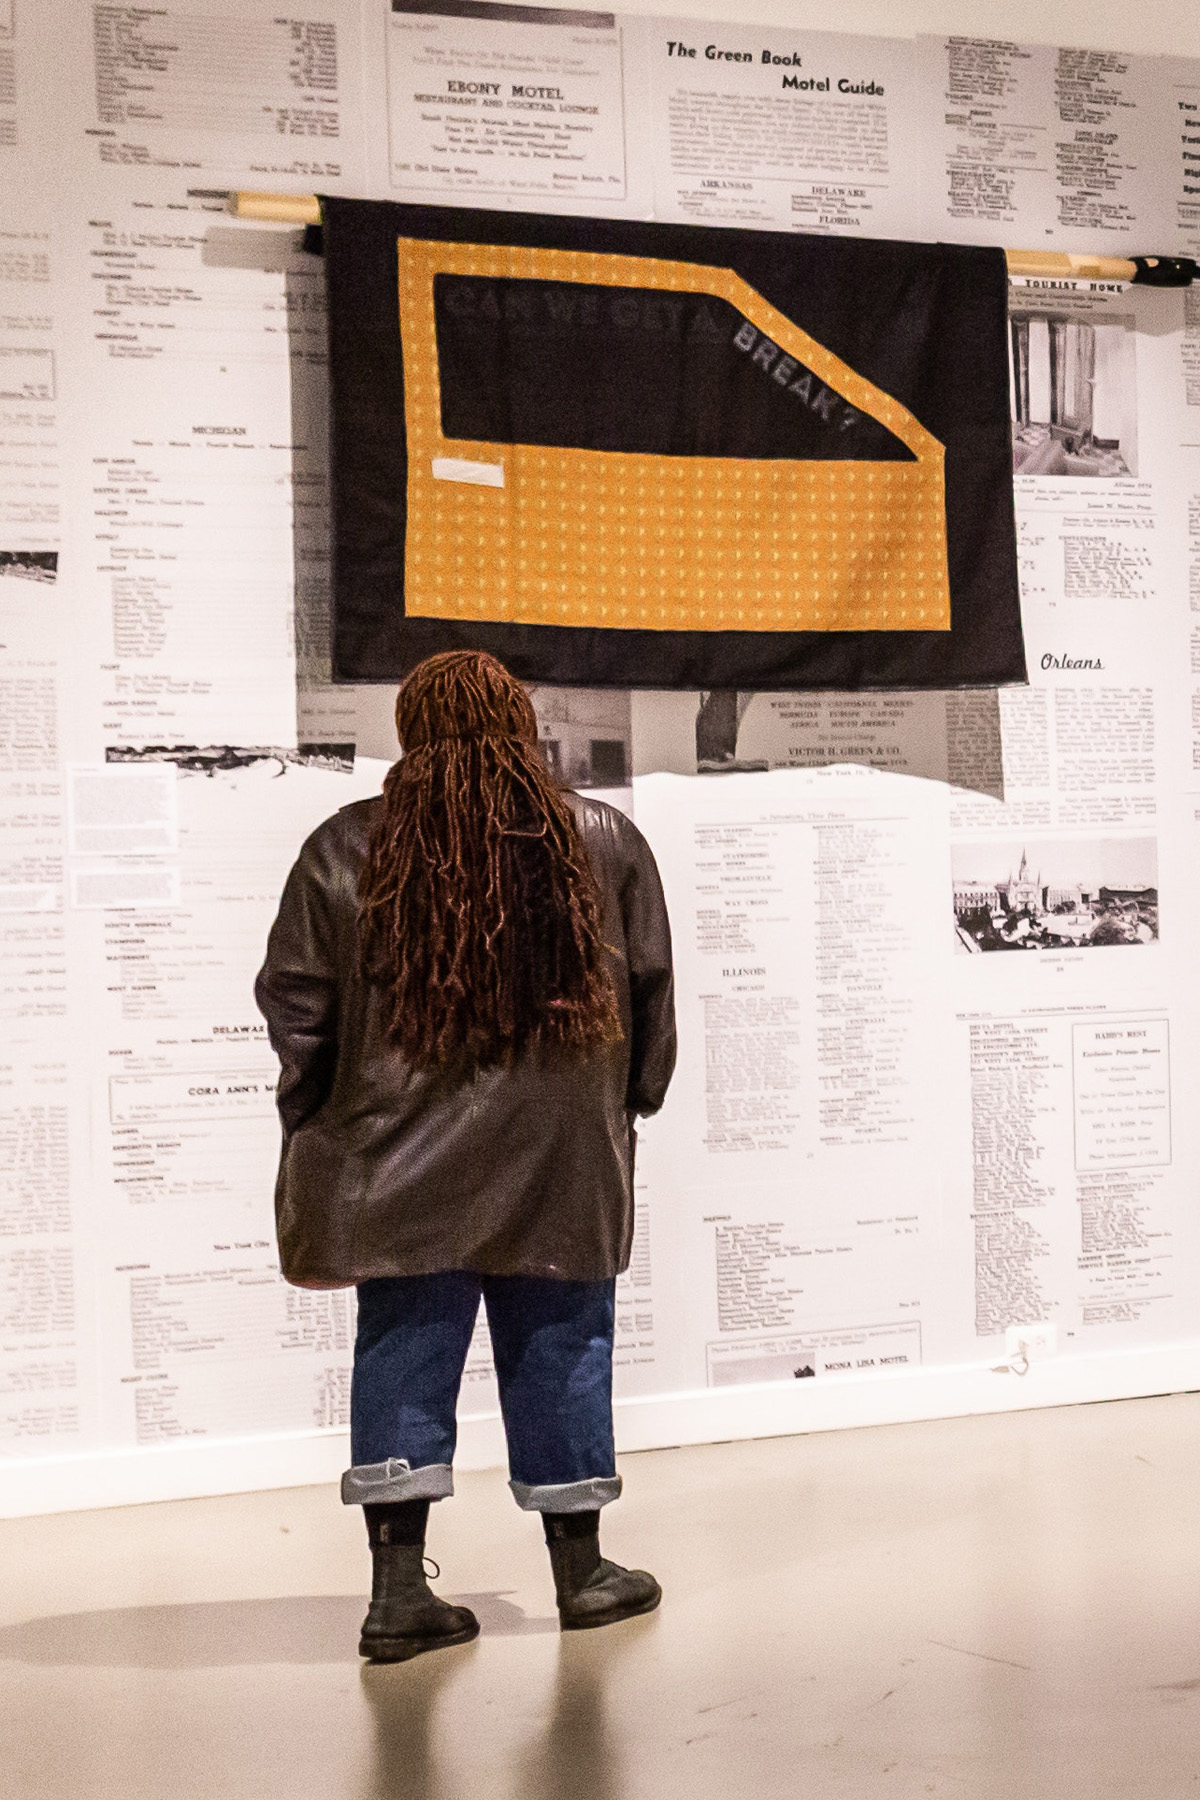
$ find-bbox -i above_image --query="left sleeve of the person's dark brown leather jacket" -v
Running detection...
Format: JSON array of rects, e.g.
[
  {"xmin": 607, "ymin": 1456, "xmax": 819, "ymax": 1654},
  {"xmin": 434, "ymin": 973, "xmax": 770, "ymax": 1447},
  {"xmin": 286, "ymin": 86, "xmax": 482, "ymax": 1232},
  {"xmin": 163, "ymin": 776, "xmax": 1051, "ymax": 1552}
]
[{"xmin": 254, "ymin": 832, "xmax": 338, "ymax": 1136}]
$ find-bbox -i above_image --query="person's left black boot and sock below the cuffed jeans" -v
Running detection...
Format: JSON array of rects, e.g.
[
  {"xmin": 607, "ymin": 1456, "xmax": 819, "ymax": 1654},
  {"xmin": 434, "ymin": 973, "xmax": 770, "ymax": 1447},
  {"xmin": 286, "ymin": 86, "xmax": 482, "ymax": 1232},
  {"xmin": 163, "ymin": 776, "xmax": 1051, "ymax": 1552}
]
[{"xmin": 358, "ymin": 1499, "xmax": 479, "ymax": 1663}]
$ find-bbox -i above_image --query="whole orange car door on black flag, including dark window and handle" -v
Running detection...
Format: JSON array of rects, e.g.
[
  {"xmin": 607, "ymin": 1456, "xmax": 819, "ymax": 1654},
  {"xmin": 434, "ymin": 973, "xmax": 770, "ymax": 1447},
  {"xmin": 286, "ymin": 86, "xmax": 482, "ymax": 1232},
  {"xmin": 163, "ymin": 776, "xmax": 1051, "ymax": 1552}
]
[{"xmin": 399, "ymin": 238, "xmax": 950, "ymax": 632}]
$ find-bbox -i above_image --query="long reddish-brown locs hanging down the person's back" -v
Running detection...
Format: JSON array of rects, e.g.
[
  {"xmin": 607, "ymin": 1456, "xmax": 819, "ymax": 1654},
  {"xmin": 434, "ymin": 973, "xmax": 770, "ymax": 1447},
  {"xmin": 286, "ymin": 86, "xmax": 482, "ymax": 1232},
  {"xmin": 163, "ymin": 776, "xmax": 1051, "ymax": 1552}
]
[{"xmin": 358, "ymin": 650, "xmax": 621, "ymax": 1071}]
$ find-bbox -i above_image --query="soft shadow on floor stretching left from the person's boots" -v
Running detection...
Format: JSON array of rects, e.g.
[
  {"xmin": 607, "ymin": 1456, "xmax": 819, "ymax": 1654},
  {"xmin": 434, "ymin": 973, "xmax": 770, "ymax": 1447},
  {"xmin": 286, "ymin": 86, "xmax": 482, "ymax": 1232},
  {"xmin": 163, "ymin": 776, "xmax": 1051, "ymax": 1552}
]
[{"xmin": 0, "ymin": 1593, "xmax": 558, "ymax": 1669}]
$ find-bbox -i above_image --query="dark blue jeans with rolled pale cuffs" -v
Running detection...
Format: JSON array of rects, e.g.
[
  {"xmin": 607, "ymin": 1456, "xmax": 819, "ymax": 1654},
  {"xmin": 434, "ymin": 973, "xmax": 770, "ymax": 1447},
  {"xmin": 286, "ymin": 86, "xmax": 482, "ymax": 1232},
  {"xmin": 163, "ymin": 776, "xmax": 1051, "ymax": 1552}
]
[{"xmin": 342, "ymin": 1271, "xmax": 621, "ymax": 1512}]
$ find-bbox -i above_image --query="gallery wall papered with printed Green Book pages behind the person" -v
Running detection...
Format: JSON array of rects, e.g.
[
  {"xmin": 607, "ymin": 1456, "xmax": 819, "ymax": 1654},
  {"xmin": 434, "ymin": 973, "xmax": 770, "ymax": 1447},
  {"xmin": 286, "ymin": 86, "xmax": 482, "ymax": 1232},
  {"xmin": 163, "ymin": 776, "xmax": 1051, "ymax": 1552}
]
[{"xmin": 0, "ymin": 0, "xmax": 1200, "ymax": 1512}]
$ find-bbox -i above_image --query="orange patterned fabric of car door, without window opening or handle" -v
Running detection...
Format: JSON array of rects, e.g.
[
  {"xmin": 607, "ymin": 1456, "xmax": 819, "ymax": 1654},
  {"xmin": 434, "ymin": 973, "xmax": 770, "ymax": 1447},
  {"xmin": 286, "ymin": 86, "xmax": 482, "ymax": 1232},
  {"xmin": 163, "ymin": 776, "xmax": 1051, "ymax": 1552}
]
[{"xmin": 398, "ymin": 238, "xmax": 950, "ymax": 632}]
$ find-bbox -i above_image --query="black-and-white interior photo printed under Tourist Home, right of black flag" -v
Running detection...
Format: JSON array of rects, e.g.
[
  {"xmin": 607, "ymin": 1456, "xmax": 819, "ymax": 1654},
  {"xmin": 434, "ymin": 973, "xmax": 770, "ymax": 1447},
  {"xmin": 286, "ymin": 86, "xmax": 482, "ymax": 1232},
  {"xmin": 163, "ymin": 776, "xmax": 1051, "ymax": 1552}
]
[{"xmin": 1009, "ymin": 311, "xmax": 1137, "ymax": 481}]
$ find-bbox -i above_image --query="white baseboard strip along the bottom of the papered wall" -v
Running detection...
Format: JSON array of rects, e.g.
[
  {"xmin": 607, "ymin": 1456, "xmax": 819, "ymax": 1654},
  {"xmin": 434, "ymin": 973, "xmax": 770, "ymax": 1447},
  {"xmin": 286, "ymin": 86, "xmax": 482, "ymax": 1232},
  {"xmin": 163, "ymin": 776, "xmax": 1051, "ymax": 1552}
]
[{"xmin": 0, "ymin": 1343, "xmax": 1200, "ymax": 1519}]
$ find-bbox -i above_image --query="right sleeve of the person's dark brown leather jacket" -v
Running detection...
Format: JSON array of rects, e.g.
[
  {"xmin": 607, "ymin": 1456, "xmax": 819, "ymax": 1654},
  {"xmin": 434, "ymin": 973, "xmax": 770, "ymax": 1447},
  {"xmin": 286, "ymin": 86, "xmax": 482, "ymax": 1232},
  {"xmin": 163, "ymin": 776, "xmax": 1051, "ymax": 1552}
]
[{"xmin": 621, "ymin": 821, "xmax": 675, "ymax": 1116}]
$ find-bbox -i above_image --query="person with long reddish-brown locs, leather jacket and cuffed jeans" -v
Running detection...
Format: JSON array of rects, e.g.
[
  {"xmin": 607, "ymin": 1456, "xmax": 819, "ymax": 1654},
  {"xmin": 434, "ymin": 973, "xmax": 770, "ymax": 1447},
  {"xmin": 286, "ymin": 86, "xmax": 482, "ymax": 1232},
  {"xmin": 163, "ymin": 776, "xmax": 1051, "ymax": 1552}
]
[{"xmin": 255, "ymin": 652, "xmax": 675, "ymax": 1661}]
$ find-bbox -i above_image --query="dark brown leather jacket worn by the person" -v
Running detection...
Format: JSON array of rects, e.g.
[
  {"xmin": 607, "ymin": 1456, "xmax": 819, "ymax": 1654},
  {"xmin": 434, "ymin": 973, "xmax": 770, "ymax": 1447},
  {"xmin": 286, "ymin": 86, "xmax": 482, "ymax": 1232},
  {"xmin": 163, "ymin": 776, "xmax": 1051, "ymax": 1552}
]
[{"xmin": 255, "ymin": 794, "xmax": 675, "ymax": 1287}]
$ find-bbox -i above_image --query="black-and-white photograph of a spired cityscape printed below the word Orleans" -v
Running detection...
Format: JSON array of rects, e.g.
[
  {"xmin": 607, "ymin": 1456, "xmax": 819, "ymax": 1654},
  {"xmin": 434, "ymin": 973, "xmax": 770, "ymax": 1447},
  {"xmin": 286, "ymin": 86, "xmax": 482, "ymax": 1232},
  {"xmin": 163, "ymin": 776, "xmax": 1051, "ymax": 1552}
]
[{"xmin": 950, "ymin": 837, "xmax": 1159, "ymax": 956}]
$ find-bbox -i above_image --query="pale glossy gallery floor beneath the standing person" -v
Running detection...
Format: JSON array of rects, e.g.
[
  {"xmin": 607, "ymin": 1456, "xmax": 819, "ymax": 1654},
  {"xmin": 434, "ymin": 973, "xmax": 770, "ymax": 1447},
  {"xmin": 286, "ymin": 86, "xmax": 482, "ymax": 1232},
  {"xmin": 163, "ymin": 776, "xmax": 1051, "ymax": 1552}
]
[{"xmin": 0, "ymin": 1395, "xmax": 1200, "ymax": 1800}]
